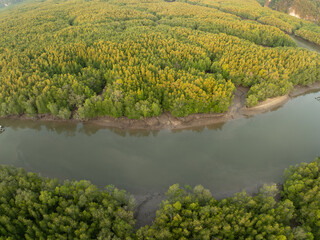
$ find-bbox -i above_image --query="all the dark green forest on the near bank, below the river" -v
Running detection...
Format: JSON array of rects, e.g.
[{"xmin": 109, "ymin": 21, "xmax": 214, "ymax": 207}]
[{"xmin": 0, "ymin": 158, "xmax": 320, "ymax": 240}]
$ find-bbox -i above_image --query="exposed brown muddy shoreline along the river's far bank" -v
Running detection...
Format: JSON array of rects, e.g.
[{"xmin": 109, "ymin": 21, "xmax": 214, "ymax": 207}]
[{"xmin": 0, "ymin": 82, "xmax": 320, "ymax": 130}]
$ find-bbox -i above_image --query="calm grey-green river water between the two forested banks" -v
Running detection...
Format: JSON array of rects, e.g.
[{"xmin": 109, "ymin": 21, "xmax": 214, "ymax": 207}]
[{"xmin": 0, "ymin": 36, "xmax": 320, "ymax": 200}]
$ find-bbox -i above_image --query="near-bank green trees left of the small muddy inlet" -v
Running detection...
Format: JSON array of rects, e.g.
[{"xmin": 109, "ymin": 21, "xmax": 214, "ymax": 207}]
[{"xmin": 0, "ymin": 167, "xmax": 134, "ymax": 240}]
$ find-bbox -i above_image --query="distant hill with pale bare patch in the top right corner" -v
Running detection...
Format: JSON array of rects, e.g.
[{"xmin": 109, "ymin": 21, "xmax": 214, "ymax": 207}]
[{"xmin": 266, "ymin": 0, "xmax": 320, "ymax": 24}]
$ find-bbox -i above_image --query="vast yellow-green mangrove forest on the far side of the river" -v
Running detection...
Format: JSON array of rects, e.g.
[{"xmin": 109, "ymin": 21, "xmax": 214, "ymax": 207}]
[{"xmin": 0, "ymin": 0, "xmax": 320, "ymax": 119}]
